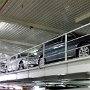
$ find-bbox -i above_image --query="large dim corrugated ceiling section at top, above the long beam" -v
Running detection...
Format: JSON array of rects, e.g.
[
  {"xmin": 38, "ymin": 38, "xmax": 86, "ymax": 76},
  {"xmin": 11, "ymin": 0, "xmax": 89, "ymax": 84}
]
[{"xmin": 3, "ymin": 0, "xmax": 90, "ymax": 30}]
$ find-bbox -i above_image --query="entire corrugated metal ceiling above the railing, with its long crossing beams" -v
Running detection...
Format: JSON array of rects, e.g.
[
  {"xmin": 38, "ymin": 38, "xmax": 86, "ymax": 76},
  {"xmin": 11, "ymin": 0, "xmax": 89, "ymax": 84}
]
[{"xmin": 0, "ymin": 0, "xmax": 90, "ymax": 55}]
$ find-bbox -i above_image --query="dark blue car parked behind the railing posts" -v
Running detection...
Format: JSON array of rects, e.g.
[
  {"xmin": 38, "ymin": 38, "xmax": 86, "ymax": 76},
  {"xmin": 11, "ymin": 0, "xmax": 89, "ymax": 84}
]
[{"xmin": 38, "ymin": 33, "xmax": 90, "ymax": 64}]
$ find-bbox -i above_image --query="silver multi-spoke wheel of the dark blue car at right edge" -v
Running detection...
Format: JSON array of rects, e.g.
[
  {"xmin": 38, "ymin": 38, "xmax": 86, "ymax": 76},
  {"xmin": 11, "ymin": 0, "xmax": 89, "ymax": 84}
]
[{"xmin": 78, "ymin": 43, "xmax": 90, "ymax": 57}]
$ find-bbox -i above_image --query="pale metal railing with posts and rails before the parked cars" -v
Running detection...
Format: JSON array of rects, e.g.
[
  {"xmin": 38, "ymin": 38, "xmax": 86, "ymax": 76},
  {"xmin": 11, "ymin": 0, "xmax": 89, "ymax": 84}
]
[{"xmin": 4, "ymin": 23, "xmax": 90, "ymax": 73}]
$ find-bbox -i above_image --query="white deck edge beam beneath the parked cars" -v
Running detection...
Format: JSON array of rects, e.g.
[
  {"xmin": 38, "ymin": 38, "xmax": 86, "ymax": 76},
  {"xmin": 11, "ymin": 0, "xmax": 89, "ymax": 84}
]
[{"xmin": 0, "ymin": 56, "xmax": 90, "ymax": 82}]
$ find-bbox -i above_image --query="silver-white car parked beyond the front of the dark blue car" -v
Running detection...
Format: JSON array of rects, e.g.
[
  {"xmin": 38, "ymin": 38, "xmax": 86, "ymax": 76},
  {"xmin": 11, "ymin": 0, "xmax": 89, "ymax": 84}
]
[{"xmin": 6, "ymin": 53, "xmax": 38, "ymax": 72}]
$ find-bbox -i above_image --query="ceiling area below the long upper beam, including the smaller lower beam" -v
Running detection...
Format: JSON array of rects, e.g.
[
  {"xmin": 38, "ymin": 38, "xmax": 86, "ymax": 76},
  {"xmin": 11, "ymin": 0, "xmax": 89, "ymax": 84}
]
[{"xmin": 0, "ymin": 22, "xmax": 59, "ymax": 55}]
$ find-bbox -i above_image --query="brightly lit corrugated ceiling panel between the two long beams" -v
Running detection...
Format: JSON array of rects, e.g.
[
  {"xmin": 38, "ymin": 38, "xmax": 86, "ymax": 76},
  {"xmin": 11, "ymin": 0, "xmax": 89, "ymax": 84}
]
[{"xmin": 0, "ymin": 22, "xmax": 58, "ymax": 44}]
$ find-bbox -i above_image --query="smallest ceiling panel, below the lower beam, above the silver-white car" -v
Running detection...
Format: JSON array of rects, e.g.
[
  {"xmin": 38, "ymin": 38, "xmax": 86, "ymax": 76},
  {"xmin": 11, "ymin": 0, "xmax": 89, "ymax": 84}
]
[{"xmin": 0, "ymin": 41, "xmax": 30, "ymax": 55}]
